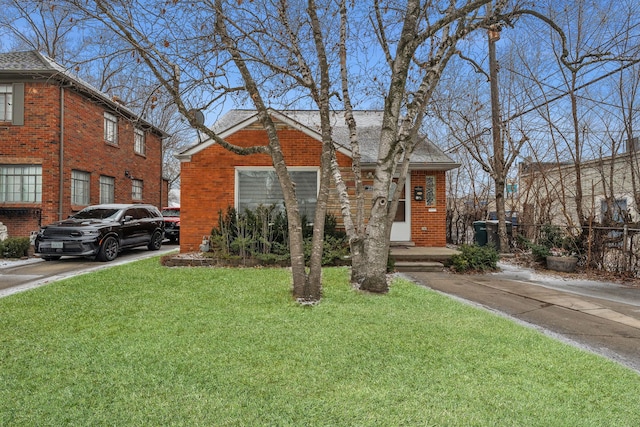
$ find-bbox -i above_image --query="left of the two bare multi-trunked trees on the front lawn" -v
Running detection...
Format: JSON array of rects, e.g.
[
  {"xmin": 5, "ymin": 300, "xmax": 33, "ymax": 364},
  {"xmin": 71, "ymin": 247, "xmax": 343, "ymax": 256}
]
[{"xmin": 47, "ymin": 0, "xmax": 348, "ymax": 302}]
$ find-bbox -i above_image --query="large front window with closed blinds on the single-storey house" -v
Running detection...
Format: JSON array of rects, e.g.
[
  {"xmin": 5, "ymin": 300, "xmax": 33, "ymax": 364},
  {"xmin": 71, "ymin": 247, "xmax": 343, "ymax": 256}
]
[{"xmin": 236, "ymin": 169, "xmax": 318, "ymax": 221}]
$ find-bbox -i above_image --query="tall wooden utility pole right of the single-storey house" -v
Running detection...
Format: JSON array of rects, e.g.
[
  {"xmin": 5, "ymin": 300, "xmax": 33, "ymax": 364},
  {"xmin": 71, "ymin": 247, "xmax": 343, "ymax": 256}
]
[{"xmin": 487, "ymin": 25, "xmax": 509, "ymax": 252}]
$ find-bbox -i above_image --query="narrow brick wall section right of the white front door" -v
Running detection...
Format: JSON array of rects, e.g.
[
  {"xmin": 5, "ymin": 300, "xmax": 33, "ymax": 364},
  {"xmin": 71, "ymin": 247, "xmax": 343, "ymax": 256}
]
[{"xmin": 407, "ymin": 171, "xmax": 447, "ymax": 247}]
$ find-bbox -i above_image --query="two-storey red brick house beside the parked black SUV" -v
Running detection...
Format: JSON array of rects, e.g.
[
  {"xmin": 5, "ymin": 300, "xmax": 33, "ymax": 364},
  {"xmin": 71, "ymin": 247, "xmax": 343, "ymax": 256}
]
[{"xmin": 0, "ymin": 51, "xmax": 168, "ymax": 237}]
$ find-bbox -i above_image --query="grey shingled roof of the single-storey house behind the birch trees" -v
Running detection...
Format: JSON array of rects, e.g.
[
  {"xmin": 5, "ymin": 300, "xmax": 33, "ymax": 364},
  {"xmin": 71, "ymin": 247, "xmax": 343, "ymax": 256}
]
[{"xmin": 178, "ymin": 110, "xmax": 459, "ymax": 170}]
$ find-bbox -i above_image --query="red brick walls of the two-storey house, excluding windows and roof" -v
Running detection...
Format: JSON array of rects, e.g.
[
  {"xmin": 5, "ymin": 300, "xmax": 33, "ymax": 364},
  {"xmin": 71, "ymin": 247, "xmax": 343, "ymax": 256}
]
[{"xmin": 0, "ymin": 82, "xmax": 167, "ymax": 237}]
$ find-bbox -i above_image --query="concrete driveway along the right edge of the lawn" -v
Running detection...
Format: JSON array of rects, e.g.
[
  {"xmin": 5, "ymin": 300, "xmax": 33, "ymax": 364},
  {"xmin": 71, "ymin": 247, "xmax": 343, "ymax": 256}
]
[{"xmin": 405, "ymin": 272, "xmax": 640, "ymax": 372}]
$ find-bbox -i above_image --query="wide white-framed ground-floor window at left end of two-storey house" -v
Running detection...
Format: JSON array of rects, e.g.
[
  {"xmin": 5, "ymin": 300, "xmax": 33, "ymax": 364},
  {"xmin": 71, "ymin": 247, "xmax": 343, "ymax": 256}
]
[{"xmin": 0, "ymin": 164, "xmax": 42, "ymax": 203}]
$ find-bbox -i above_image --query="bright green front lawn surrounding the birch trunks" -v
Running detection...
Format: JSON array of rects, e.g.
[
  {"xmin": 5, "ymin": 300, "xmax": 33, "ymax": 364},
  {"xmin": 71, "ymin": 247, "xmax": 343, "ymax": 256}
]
[{"xmin": 0, "ymin": 259, "xmax": 640, "ymax": 426}]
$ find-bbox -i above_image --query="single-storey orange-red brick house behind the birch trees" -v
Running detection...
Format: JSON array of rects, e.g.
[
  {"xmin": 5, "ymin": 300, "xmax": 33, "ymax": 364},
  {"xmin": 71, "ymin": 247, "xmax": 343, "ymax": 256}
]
[{"xmin": 177, "ymin": 110, "xmax": 459, "ymax": 252}]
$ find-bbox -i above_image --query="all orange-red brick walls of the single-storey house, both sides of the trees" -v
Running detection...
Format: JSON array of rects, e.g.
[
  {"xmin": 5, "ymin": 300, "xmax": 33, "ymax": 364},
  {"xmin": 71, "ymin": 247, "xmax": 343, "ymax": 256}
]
[{"xmin": 180, "ymin": 121, "xmax": 446, "ymax": 252}]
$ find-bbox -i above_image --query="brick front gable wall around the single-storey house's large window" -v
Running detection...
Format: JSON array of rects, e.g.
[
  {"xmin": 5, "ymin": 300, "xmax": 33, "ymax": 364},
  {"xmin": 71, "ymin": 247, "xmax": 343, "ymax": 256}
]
[{"xmin": 180, "ymin": 127, "xmax": 350, "ymax": 252}]
